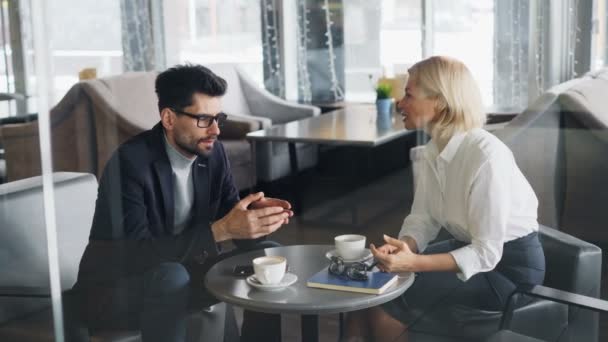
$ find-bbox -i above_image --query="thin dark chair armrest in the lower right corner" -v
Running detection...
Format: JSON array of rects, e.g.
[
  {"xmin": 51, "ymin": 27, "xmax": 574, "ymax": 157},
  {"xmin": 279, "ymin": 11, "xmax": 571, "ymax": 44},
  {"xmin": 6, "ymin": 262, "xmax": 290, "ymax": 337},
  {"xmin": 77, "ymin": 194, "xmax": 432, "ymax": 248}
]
[{"xmin": 500, "ymin": 285, "xmax": 608, "ymax": 329}]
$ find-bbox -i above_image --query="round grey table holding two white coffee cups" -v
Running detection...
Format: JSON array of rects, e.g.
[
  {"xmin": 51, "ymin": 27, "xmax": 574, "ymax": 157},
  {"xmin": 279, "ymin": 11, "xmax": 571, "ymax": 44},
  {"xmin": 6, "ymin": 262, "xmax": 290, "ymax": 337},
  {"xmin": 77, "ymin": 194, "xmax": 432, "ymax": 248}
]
[{"xmin": 205, "ymin": 245, "xmax": 414, "ymax": 341}]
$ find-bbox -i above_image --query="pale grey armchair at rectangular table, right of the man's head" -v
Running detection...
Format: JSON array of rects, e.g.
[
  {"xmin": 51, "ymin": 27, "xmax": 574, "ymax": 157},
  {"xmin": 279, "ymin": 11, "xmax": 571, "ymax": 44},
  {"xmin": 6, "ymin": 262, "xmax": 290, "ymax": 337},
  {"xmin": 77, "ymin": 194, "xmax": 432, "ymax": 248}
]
[{"xmin": 209, "ymin": 64, "xmax": 321, "ymax": 182}]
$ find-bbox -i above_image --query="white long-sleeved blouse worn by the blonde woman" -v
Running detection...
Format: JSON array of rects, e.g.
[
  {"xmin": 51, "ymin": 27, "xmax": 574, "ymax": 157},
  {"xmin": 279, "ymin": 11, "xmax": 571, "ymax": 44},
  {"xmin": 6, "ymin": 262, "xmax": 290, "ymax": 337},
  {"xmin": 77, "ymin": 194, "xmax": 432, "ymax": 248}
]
[{"xmin": 399, "ymin": 129, "xmax": 538, "ymax": 281}]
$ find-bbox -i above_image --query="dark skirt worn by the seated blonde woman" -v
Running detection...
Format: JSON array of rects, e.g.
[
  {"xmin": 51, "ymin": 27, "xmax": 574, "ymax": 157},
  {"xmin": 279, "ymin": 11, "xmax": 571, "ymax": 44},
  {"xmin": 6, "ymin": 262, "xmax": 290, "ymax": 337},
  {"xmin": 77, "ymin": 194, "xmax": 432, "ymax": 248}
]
[{"xmin": 382, "ymin": 232, "xmax": 545, "ymax": 331}]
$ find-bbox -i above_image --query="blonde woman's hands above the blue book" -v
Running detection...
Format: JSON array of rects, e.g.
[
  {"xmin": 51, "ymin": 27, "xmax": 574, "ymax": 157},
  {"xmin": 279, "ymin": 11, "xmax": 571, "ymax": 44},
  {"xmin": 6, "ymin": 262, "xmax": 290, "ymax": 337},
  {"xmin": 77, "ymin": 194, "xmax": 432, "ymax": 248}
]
[{"xmin": 370, "ymin": 235, "xmax": 418, "ymax": 272}]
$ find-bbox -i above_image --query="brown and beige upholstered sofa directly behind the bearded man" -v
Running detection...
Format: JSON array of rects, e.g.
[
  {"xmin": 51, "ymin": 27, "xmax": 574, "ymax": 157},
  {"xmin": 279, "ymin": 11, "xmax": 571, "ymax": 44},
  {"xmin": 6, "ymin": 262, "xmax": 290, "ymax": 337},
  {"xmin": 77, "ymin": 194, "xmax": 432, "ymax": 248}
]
[{"xmin": 0, "ymin": 72, "xmax": 262, "ymax": 190}]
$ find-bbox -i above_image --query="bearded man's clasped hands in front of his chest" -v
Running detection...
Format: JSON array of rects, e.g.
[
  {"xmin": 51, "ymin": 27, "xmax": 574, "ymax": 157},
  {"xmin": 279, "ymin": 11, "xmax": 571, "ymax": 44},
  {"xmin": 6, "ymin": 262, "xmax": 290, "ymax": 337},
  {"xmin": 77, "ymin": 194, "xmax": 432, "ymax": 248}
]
[{"xmin": 211, "ymin": 192, "xmax": 293, "ymax": 242}]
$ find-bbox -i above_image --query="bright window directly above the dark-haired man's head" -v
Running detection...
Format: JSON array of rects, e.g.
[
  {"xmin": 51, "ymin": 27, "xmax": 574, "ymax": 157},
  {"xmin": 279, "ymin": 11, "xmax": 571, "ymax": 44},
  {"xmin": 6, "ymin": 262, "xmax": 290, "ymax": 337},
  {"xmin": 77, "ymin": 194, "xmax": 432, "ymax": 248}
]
[{"xmin": 163, "ymin": 0, "xmax": 263, "ymax": 84}]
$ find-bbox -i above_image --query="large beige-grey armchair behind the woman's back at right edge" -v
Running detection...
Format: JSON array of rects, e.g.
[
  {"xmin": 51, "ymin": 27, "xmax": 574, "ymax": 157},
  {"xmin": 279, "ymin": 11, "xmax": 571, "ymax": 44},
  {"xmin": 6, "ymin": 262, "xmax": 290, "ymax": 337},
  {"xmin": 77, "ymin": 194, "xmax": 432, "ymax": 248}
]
[{"xmin": 494, "ymin": 69, "xmax": 608, "ymax": 242}]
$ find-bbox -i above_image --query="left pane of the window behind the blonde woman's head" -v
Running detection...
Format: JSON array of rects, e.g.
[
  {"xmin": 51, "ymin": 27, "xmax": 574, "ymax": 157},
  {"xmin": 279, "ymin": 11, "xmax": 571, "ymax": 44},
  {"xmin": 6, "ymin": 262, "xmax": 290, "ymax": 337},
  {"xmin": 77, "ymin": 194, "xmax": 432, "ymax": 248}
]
[{"xmin": 344, "ymin": 0, "xmax": 422, "ymax": 102}]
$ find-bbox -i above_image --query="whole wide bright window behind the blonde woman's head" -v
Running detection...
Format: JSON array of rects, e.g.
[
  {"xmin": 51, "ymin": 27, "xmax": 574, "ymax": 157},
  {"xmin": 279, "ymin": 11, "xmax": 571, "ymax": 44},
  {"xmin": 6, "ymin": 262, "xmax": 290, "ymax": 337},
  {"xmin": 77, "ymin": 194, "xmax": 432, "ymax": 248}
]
[{"xmin": 344, "ymin": 0, "xmax": 494, "ymax": 105}]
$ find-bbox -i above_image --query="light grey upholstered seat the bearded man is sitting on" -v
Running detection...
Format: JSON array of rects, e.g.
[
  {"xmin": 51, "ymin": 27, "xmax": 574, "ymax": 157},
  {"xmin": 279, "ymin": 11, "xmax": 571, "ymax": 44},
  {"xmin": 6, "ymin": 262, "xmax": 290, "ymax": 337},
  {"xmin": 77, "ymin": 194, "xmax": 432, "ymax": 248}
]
[{"xmin": 0, "ymin": 172, "xmax": 238, "ymax": 342}]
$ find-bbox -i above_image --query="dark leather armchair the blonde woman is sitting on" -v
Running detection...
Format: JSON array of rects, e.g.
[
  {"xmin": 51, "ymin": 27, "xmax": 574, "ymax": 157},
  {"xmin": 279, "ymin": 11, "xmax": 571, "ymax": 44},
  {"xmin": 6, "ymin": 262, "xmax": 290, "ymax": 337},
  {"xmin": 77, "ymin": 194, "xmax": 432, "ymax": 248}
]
[{"xmin": 410, "ymin": 226, "xmax": 602, "ymax": 342}]
